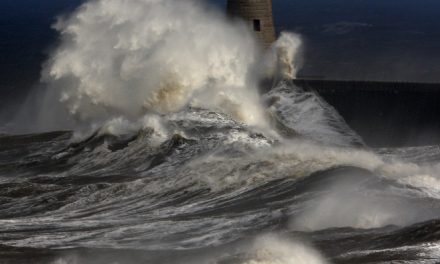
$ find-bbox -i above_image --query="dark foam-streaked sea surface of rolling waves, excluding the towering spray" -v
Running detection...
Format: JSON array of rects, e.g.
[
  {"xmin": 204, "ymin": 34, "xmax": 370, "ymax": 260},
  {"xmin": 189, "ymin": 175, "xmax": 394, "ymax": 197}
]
[{"xmin": 0, "ymin": 82, "xmax": 440, "ymax": 263}]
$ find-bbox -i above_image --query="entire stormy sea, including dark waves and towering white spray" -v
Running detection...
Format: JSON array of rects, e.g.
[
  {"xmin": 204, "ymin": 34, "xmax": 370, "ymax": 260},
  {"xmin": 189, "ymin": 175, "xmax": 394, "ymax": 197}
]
[{"xmin": 0, "ymin": 0, "xmax": 440, "ymax": 264}]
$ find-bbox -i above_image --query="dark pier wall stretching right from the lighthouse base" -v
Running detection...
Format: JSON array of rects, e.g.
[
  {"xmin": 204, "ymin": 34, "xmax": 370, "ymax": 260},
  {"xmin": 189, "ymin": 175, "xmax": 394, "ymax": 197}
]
[{"xmin": 294, "ymin": 79, "xmax": 440, "ymax": 147}]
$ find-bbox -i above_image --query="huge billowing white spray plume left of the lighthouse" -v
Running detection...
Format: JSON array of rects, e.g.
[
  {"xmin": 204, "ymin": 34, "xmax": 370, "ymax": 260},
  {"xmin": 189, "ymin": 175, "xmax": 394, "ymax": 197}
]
[{"xmin": 31, "ymin": 0, "xmax": 288, "ymax": 132}]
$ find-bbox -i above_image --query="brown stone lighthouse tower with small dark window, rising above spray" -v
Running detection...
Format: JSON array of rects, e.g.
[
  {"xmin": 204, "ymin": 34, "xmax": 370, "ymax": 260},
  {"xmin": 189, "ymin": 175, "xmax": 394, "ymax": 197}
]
[{"xmin": 228, "ymin": 0, "xmax": 276, "ymax": 48}]
